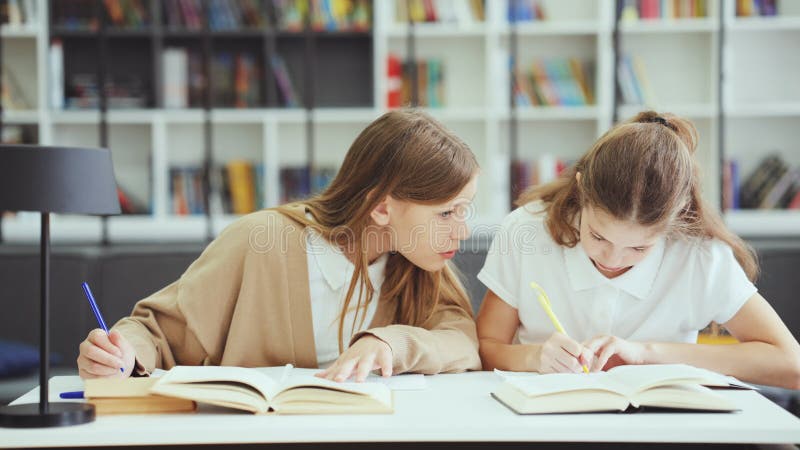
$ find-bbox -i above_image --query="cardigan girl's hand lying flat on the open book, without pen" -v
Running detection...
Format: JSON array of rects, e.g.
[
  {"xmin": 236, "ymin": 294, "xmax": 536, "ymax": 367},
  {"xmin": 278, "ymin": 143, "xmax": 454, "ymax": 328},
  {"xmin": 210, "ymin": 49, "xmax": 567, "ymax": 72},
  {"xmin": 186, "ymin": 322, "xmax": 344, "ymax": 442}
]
[{"xmin": 316, "ymin": 335, "xmax": 392, "ymax": 383}]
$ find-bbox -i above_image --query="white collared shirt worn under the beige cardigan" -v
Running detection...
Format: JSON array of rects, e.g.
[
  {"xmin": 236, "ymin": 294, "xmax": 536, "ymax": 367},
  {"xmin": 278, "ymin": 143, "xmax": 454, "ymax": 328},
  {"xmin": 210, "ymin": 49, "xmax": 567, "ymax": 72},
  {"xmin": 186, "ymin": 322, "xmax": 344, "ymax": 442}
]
[{"xmin": 306, "ymin": 227, "xmax": 389, "ymax": 368}]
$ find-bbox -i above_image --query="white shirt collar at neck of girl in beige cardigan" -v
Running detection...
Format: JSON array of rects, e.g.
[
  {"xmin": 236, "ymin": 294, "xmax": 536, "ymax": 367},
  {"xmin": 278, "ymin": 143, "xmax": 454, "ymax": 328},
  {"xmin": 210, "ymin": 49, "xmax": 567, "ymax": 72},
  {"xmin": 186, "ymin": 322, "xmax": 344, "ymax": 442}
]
[{"xmin": 306, "ymin": 227, "xmax": 389, "ymax": 291}]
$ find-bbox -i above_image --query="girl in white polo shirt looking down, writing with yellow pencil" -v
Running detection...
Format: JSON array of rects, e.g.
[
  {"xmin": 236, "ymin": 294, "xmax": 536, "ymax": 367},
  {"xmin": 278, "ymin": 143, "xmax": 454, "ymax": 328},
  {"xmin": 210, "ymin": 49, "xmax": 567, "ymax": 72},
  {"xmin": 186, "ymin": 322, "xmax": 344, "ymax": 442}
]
[{"xmin": 477, "ymin": 111, "xmax": 800, "ymax": 389}]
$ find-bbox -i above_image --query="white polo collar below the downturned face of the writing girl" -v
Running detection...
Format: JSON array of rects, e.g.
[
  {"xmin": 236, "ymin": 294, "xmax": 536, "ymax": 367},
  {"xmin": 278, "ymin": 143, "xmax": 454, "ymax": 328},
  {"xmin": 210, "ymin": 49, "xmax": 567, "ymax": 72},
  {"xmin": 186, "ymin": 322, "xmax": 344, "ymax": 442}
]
[{"xmin": 564, "ymin": 238, "xmax": 665, "ymax": 300}]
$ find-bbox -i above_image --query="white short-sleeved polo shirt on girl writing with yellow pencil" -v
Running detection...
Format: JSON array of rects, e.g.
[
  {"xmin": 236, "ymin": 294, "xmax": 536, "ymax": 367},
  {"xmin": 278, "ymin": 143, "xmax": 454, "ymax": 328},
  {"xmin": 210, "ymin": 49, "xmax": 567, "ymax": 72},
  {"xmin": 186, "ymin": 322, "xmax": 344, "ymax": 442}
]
[{"xmin": 478, "ymin": 202, "xmax": 757, "ymax": 343}]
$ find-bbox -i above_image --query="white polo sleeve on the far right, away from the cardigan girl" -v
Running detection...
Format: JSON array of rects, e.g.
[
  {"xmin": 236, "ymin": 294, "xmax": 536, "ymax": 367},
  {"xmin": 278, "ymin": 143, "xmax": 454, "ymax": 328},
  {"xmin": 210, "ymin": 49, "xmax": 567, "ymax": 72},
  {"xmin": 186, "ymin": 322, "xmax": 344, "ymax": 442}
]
[{"xmin": 695, "ymin": 239, "xmax": 758, "ymax": 326}]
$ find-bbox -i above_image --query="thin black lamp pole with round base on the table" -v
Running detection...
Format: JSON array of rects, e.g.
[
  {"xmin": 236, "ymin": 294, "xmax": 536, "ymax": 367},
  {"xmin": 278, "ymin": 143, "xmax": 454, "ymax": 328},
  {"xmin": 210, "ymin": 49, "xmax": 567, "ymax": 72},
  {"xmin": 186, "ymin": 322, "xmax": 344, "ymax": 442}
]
[{"xmin": 0, "ymin": 212, "xmax": 94, "ymax": 428}]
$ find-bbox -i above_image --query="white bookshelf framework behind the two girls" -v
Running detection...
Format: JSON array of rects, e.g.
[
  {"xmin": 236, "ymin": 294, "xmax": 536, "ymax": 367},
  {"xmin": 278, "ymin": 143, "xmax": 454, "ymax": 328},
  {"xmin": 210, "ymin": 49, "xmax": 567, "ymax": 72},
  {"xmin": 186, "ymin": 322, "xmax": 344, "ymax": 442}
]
[{"xmin": 0, "ymin": 0, "xmax": 800, "ymax": 242}]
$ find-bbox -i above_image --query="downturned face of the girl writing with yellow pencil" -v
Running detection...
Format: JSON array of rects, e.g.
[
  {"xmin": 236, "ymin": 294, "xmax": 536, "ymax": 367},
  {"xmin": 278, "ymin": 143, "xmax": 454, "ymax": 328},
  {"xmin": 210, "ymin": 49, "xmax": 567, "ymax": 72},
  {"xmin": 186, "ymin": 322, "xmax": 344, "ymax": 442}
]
[{"xmin": 580, "ymin": 206, "xmax": 662, "ymax": 278}]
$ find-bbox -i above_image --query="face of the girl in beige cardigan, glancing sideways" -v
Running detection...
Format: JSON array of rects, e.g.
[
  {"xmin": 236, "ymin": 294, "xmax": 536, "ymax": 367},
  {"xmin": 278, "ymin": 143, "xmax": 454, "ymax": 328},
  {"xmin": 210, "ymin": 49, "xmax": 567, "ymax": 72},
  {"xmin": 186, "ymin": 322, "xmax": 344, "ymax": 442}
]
[{"xmin": 380, "ymin": 175, "xmax": 478, "ymax": 272}]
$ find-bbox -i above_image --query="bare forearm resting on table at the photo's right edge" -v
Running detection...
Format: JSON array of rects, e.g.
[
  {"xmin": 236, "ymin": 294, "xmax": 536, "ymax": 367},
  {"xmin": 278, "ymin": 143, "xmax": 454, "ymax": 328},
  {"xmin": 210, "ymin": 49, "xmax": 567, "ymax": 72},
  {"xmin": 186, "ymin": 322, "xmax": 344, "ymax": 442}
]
[{"xmin": 643, "ymin": 342, "xmax": 800, "ymax": 389}]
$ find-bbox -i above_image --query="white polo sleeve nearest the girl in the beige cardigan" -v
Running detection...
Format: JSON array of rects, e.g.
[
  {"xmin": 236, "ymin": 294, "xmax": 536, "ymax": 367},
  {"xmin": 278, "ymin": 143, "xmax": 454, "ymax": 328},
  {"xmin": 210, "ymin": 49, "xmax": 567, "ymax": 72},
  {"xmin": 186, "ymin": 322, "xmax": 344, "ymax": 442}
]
[{"xmin": 478, "ymin": 210, "xmax": 541, "ymax": 308}]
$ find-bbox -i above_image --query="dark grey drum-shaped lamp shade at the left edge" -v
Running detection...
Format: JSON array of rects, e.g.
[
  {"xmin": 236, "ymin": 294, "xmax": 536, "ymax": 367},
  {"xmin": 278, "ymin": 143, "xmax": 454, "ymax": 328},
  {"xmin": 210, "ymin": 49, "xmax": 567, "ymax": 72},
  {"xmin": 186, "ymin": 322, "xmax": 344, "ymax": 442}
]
[{"xmin": 0, "ymin": 145, "xmax": 120, "ymax": 215}]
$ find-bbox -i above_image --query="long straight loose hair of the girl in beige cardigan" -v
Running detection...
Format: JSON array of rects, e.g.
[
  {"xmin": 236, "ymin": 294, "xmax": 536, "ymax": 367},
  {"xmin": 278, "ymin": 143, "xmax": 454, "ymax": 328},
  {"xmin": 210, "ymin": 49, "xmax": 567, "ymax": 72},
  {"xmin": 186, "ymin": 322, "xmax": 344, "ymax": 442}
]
[{"xmin": 277, "ymin": 110, "xmax": 478, "ymax": 351}]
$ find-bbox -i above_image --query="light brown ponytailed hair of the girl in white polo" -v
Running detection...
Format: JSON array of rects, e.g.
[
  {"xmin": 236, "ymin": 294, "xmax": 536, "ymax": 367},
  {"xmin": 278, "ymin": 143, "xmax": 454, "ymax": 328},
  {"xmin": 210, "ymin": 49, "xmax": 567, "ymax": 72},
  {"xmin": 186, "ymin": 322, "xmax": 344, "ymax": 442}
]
[{"xmin": 517, "ymin": 111, "xmax": 759, "ymax": 281}]
